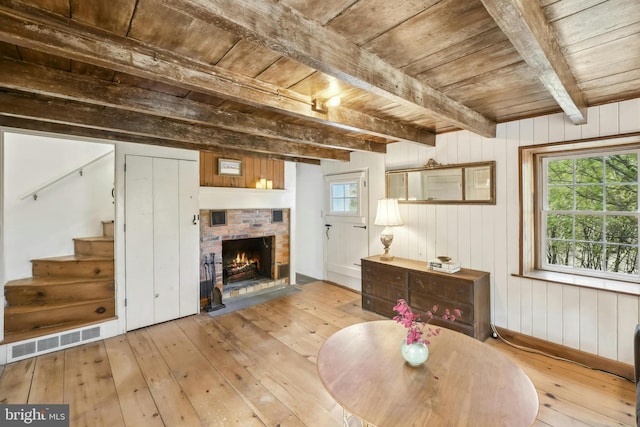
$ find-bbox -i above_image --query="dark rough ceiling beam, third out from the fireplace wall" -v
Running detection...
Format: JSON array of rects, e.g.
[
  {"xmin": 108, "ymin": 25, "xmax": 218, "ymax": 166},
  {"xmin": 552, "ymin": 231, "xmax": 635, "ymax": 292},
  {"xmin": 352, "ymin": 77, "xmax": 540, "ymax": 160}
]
[{"xmin": 0, "ymin": 58, "xmax": 387, "ymax": 153}]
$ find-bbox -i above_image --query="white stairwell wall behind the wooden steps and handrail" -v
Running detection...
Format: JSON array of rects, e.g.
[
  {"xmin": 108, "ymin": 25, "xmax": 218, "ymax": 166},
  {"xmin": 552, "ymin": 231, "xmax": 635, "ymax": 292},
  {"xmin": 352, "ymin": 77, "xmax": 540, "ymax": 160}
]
[{"xmin": 3, "ymin": 131, "xmax": 115, "ymax": 283}]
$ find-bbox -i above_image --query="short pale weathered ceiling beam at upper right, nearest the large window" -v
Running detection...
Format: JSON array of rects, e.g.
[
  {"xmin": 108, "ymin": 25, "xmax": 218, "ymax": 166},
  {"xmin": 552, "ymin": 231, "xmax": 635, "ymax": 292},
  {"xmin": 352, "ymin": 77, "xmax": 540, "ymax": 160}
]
[{"xmin": 482, "ymin": 0, "xmax": 587, "ymax": 125}]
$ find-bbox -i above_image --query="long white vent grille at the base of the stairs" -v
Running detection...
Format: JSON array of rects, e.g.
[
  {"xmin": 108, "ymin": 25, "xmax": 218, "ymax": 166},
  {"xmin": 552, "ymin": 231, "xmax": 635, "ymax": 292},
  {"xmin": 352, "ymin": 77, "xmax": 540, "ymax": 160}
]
[{"xmin": 7, "ymin": 326, "xmax": 102, "ymax": 363}]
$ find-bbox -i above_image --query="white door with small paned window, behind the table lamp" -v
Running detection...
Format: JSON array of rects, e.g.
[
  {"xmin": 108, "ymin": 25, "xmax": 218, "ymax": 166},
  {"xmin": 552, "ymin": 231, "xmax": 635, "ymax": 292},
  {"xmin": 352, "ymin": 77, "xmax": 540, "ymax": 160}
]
[{"xmin": 324, "ymin": 171, "xmax": 369, "ymax": 290}]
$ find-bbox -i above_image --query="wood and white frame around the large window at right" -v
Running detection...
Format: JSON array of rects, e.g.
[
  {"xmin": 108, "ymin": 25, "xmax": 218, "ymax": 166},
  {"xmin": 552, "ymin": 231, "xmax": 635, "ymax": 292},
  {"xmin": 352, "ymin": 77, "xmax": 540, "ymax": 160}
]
[{"xmin": 515, "ymin": 133, "xmax": 640, "ymax": 288}]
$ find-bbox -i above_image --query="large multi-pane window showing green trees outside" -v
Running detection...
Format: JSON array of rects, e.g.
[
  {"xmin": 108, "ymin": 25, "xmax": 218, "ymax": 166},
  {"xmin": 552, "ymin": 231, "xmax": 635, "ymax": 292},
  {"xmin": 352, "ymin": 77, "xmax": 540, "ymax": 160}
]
[{"xmin": 539, "ymin": 150, "xmax": 640, "ymax": 278}]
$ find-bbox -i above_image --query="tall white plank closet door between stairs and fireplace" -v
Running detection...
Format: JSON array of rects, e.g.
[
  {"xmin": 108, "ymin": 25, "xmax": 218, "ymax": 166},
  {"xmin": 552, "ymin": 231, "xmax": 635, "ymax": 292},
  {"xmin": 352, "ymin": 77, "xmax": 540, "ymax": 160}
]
[{"xmin": 125, "ymin": 155, "xmax": 199, "ymax": 330}]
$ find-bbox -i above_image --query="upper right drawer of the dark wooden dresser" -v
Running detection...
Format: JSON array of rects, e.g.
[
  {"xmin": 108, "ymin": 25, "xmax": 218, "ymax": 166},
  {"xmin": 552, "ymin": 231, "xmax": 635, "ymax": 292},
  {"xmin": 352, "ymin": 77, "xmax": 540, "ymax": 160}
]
[{"xmin": 409, "ymin": 272, "xmax": 473, "ymax": 304}]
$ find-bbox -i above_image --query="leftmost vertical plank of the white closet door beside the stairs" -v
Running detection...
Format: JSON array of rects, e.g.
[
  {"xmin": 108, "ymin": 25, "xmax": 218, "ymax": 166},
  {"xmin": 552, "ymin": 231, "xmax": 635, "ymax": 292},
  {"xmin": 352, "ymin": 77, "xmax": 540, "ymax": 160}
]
[{"xmin": 125, "ymin": 156, "xmax": 154, "ymax": 330}]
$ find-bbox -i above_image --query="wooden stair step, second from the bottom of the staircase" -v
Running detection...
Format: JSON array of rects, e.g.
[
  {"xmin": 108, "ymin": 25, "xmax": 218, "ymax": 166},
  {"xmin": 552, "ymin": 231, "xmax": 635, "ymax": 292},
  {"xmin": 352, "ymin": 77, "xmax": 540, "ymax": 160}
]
[{"xmin": 4, "ymin": 276, "xmax": 115, "ymax": 306}]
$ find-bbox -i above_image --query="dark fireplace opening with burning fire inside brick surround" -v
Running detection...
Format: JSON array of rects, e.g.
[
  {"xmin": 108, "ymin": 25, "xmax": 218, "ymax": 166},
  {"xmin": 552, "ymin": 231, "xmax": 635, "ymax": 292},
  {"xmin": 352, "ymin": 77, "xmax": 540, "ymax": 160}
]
[{"xmin": 222, "ymin": 236, "xmax": 274, "ymax": 287}]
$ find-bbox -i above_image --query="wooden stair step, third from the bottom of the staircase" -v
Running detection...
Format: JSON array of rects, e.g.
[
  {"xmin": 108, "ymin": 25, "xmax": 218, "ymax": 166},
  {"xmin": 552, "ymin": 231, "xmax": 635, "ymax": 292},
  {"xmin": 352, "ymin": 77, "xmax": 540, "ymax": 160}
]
[{"xmin": 31, "ymin": 255, "xmax": 114, "ymax": 278}]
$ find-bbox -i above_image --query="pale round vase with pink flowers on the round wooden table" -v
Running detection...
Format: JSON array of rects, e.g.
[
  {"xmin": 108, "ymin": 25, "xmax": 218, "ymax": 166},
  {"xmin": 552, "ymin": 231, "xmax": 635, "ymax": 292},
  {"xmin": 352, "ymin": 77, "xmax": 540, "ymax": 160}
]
[{"xmin": 393, "ymin": 299, "xmax": 462, "ymax": 367}]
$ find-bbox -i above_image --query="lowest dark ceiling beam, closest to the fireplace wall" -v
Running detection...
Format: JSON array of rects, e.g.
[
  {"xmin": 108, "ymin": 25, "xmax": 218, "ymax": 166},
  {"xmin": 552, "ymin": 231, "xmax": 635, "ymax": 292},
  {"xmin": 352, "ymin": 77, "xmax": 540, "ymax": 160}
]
[{"xmin": 0, "ymin": 115, "xmax": 320, "ymax": 165}]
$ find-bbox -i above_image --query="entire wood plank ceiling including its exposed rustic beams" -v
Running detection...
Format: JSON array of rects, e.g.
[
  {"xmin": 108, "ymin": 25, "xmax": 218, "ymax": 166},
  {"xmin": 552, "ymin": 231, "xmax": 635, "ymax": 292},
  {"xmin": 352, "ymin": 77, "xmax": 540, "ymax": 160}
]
[{"xmin": 0, "ymin": 0, "xmax": 640, "ymax": 163}]
